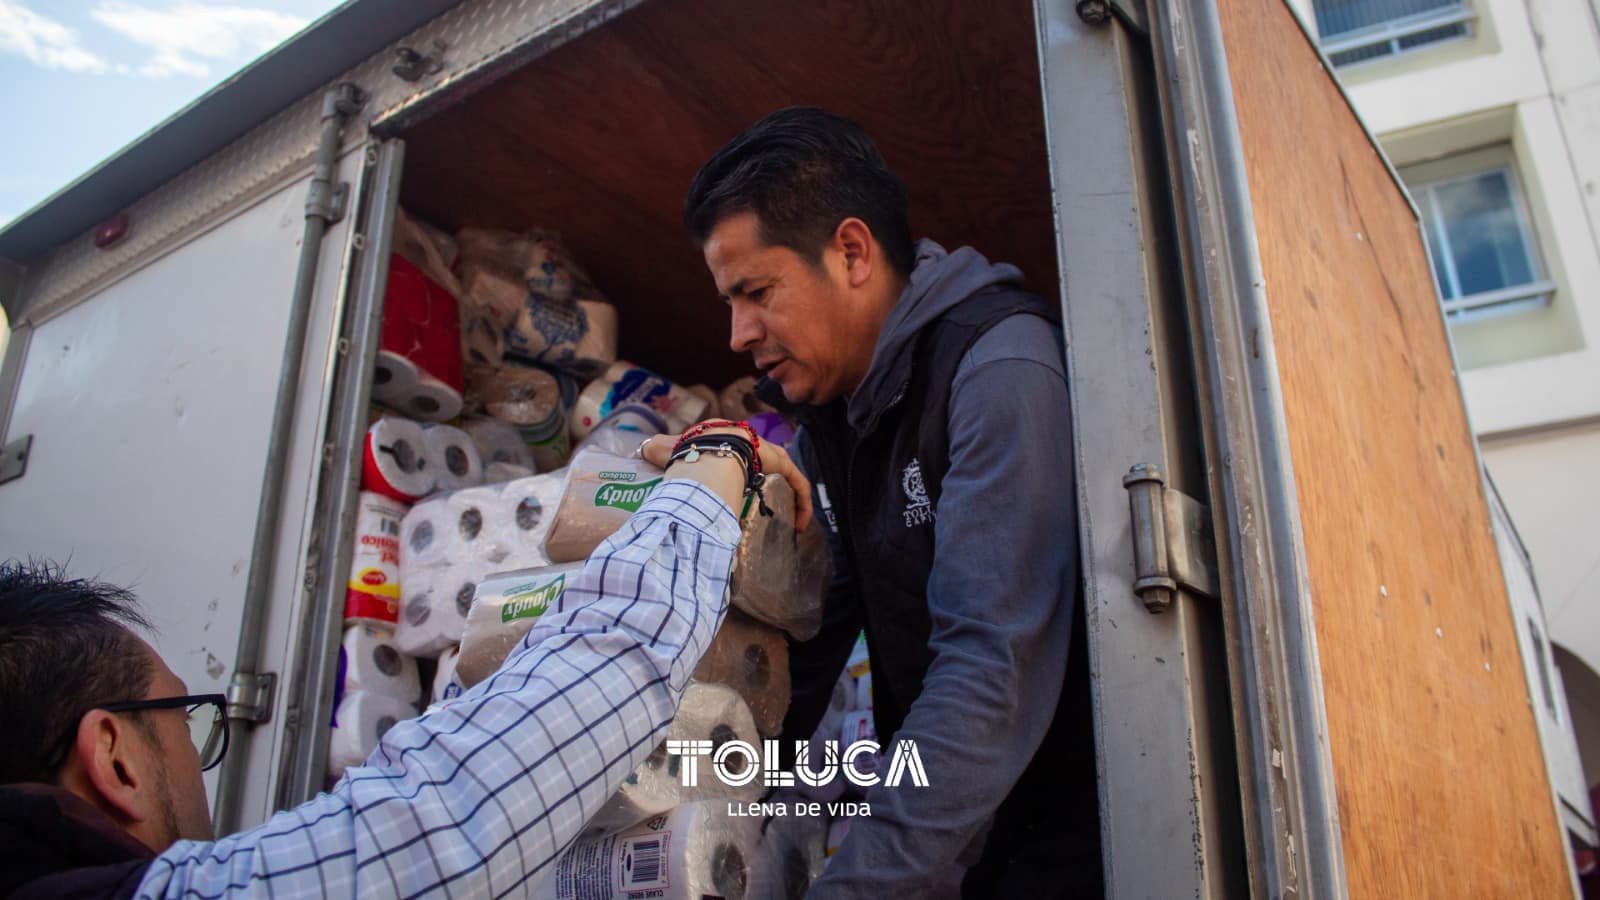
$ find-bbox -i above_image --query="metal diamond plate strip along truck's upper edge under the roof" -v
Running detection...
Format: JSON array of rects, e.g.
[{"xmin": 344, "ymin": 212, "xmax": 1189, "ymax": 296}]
[{"xmin": 24, "ymin": 0, "xmax": 638, "ymax": 323}]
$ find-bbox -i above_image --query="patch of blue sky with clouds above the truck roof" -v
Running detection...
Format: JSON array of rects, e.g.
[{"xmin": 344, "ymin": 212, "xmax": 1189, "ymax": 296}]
[{"xmin": 0, "ymin": 0, "xmax": 341, "ymax": 226}]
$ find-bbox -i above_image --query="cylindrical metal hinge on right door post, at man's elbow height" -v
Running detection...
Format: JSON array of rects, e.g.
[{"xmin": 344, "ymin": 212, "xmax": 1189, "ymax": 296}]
[{"xmin": 1122, "ymin": 463, "xmax": 1221, "ymax": 613}]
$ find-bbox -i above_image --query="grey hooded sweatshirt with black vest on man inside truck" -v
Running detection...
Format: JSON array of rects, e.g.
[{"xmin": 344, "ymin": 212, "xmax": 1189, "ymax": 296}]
[{"xmin": 786, "ymin": 242, "xmax": 1099, "ymax": 900}]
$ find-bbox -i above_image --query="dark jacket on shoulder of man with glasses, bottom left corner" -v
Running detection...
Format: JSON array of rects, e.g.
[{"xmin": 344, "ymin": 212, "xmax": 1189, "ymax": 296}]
[{"xmin": 0, "ymin": 785, "xmax": 155, "ymax": 900}]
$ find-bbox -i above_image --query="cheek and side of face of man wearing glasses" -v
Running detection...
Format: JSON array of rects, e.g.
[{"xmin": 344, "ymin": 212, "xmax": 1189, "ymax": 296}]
[{"xmin": 139, "ymin": 644, "xmax": 211, "ymax": 846}]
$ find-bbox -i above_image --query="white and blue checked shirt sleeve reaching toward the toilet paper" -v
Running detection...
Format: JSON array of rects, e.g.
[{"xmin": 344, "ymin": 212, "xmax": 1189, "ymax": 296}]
[{"xmin": 138, "ymin": 480, "xmax": 739, "ymax": 898}]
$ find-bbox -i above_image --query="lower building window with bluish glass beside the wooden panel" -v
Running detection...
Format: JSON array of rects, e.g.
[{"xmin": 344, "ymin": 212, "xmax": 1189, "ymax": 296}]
[{"xmin": 1403, "ymin": 149, "xmax": 1555, "ymax": 315}]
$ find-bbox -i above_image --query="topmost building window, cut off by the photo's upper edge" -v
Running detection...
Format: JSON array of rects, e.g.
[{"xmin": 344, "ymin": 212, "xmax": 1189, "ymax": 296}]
[{"xmin": 1312, "ymin": 0, "xmax": 1472, "ymax": 66}]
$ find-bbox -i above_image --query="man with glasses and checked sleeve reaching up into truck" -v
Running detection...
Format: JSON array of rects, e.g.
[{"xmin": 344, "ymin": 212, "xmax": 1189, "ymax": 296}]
[{"xmin": 0, "ymin": 428, "xmax": 811, "ymax": 897}]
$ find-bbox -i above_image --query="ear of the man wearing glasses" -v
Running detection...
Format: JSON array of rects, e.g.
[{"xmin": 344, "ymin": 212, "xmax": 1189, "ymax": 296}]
[{"xmin": 61, "ymin": 709, "xmax": 160, "ymax": 830}]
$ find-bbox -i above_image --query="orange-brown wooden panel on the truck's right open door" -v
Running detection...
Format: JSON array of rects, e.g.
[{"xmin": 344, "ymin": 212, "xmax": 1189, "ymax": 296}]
[{"xmin": 1219, "ymin": 0, "xmax": 1568, "ymax": 898}]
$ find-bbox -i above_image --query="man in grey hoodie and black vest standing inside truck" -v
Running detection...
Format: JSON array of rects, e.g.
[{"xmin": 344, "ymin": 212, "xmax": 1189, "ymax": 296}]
[{"xmin": 685, "ymin": 107, "xmax": 1101, "ymax": 900}]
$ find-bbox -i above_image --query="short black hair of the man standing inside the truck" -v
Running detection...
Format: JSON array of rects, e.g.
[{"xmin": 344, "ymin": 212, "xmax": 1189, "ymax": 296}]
[{"xmin": 683, "ymin": 106, "xmax": 915, "ymax": 275}]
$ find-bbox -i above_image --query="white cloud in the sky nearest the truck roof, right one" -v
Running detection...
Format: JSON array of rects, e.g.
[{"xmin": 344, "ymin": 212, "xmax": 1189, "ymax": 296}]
[{"xmin": 89, "ymin": 0, "xmax": 306, "ymax": 78}]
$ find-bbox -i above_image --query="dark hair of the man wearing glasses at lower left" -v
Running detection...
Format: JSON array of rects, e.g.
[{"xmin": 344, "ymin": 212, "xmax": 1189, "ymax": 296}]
[{"xmin": 0, "ymin": 560, "xmax": 154, "ymax": 785}]
